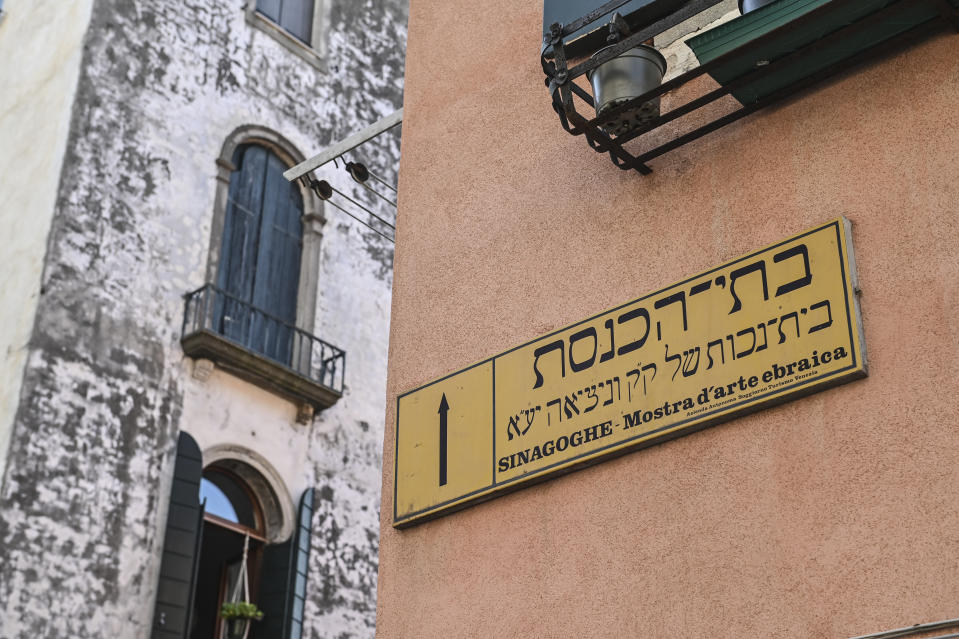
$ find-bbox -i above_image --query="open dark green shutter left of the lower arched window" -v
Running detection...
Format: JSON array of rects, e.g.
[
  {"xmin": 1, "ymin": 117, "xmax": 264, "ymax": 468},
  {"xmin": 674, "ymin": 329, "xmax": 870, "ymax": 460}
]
[{"xmin": 151, "ymin": 433, "xmax": 203, "ymax": 639}]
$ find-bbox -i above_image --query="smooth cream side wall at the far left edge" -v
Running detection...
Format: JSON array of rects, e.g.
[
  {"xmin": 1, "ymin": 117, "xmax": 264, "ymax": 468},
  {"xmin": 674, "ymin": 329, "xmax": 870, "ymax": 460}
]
[{"xmin": 0, "ymin": 0, "xmax": 93, "ymax": 492}]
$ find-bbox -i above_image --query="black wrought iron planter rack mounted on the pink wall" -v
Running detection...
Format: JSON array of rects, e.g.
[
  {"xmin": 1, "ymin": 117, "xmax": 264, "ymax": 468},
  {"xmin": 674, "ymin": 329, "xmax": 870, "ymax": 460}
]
[{"xmin": 540, "ymin": 0, "xmax": 959, "ymax": 175}]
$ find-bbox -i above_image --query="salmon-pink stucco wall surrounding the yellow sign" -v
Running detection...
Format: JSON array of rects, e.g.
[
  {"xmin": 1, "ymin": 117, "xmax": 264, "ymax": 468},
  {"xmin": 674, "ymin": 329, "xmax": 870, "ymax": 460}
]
[{"xmin": 377, "ymin": 0, "xmax": 959, "ymax": 638}]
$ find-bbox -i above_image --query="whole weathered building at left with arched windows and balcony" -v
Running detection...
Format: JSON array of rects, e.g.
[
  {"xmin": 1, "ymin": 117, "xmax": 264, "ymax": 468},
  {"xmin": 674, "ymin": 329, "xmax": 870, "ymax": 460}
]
[{"xmin": 0, "ymin": 0, "xmax": 407, "ymax": 638}]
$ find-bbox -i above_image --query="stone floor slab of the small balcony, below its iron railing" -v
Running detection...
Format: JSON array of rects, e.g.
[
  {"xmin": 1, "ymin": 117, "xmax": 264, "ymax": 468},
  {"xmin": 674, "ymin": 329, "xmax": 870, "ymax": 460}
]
[{"xmin": 180, "ymin": 329, "xmax": 343, "ymax": 410}]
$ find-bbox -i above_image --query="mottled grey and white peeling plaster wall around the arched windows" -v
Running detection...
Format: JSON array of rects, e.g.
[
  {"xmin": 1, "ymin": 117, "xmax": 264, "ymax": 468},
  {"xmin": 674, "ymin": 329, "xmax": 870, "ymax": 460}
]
[{"xmin": 0, "ymin": 0, "xmax": 407, "ymax": 639}]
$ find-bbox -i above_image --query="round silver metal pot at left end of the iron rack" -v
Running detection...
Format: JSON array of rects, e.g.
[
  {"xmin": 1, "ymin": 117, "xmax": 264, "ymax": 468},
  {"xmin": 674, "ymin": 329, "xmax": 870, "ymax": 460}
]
[{"xmin": 587, "ymin": 45, "xmax": 666, "ymax": 135}]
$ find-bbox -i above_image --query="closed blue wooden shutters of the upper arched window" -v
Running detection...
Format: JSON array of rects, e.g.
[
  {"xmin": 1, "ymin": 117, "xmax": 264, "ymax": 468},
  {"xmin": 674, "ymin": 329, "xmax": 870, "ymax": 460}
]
[{"xmin": 216, "ymin": 144, "xmax": 303, "ymax": 363}]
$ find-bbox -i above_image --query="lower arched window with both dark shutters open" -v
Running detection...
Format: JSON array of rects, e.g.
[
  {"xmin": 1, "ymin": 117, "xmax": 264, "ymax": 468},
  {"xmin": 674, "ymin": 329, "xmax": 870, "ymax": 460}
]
[{"xmin": 151, "ymin": 433, "xmax": 314, "ymax": 639}]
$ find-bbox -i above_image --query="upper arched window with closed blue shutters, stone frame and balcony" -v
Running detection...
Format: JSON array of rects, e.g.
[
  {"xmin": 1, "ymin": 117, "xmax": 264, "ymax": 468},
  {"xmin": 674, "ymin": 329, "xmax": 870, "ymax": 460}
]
[{"xmin": 180, "ymin": 125, "xmax": 338, "ymax": 422}]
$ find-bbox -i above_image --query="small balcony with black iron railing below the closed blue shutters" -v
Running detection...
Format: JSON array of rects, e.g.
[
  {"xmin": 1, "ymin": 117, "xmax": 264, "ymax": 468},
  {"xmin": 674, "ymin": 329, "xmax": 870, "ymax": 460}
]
[{"xmin": 180, "ymin": 284, "xmax": 346, "ymax": 409}]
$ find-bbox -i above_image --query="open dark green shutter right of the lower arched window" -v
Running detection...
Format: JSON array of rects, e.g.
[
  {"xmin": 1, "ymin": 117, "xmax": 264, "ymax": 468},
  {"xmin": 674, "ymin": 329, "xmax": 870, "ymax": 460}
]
[{"xmin": 251, "ymin": 488, "xmax": 313, "ymax": 639}]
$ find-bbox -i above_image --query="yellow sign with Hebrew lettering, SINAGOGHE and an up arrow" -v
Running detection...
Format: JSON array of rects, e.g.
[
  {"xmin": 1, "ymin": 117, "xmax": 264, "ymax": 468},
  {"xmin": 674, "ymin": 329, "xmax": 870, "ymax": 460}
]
[{"xmin": 393, "ymin": 219, "xmax": 866, "ymax": 526}]
